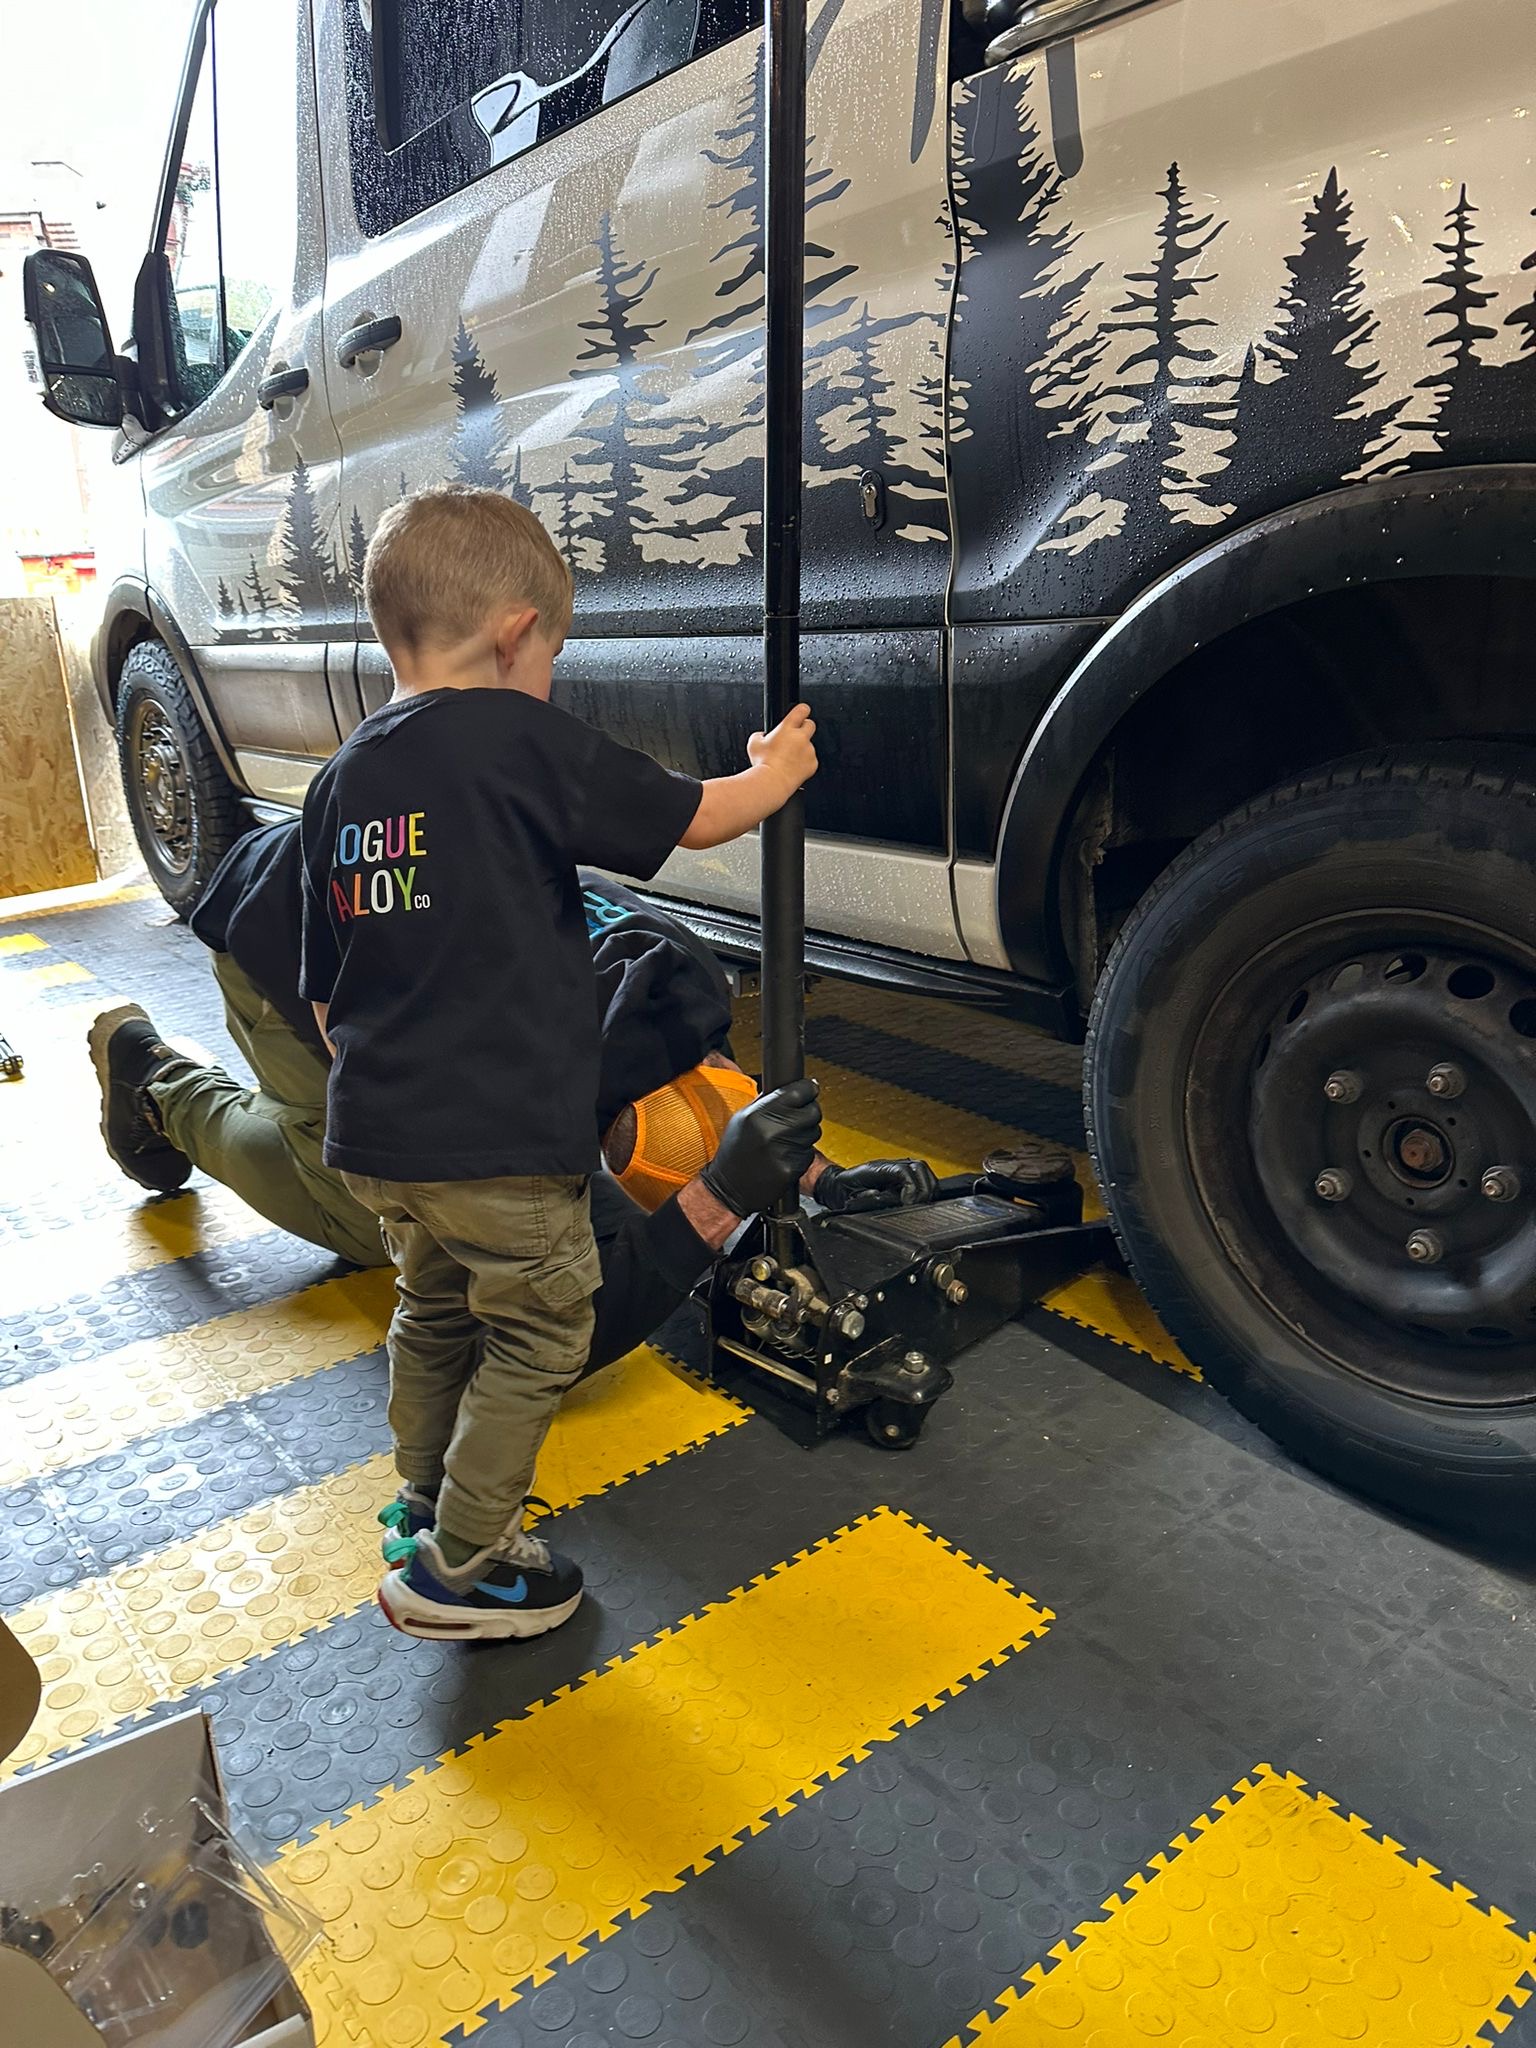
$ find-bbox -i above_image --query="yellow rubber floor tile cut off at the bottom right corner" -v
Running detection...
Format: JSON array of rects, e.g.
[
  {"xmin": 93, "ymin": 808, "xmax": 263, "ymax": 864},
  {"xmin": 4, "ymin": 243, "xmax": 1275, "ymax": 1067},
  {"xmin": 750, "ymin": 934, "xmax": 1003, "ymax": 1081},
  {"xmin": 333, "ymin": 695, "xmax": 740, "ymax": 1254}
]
[{"xmin": 950, "ymin": 1763, "xmax": 1536, "ymax": 2048}]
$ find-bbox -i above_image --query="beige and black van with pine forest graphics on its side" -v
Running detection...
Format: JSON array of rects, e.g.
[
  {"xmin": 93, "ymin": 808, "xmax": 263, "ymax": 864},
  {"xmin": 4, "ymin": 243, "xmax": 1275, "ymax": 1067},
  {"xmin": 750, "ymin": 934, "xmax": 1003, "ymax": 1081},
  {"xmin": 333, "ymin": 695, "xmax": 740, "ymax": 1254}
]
[{"xmin": 29, "ymin": 0, "xmax": 1536, "ymax": 1526}]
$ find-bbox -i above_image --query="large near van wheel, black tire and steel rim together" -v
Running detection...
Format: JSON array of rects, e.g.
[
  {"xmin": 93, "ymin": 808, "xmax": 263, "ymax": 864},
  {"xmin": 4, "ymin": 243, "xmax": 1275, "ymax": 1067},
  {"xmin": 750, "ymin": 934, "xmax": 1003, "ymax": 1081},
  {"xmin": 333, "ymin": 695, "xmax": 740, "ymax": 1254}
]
[{"xmin": 1085, "ymin": 748, "xmax": 1536, "ymax": 1536}]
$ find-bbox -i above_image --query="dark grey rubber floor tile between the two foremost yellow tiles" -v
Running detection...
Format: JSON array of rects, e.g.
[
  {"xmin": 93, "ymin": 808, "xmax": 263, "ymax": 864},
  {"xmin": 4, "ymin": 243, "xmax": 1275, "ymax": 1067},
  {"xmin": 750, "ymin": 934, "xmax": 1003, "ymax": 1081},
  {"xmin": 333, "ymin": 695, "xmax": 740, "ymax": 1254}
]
[{"xmin": 450, "ymin": 1626, "xmax": 1247, "ymax": 2048}]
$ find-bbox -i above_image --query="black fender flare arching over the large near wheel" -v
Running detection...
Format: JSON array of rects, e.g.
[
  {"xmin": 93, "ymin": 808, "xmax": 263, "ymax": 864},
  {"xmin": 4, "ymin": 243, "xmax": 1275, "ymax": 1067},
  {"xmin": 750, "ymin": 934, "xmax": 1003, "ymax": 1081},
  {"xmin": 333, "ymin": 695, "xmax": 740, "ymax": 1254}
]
[{"xmin": 997, "ymin": 463, "xmax": 1536, "ymax": 977}]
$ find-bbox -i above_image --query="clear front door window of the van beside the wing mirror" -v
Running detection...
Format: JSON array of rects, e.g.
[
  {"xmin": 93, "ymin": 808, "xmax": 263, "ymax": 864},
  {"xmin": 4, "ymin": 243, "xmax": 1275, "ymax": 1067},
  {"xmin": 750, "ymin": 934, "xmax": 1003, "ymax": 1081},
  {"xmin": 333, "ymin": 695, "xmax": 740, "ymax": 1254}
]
[{"xmin": 164, "ymin": 0, "xmax": 299, "ymax": 410}]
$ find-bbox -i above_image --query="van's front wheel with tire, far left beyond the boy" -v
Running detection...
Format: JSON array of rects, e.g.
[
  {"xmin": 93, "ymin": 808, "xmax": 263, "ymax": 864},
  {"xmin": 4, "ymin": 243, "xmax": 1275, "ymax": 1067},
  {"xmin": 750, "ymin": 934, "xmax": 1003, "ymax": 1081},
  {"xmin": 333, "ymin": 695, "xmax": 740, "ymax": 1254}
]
[{"xmin": 117, "ymin": 641, "xmax": 250, "ymax": 918}]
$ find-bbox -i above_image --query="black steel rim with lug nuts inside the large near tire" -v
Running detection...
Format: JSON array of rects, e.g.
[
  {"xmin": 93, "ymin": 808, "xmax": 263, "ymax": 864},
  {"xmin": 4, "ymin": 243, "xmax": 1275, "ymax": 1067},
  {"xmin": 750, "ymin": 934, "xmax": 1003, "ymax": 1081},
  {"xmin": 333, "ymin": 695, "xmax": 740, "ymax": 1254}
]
[{"xmin": 1249, "ymin": 946, "xmax": 1536, "ymax": 1366}]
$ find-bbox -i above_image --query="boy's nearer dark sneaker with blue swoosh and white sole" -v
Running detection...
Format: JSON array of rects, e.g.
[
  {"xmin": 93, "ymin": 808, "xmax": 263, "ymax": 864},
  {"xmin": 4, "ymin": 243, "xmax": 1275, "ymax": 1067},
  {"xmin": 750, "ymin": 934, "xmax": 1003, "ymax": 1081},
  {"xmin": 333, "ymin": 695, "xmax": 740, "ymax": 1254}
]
[{"xmin": 379, "ymin": 1530, "xmax": 582, "ymax": 1642}]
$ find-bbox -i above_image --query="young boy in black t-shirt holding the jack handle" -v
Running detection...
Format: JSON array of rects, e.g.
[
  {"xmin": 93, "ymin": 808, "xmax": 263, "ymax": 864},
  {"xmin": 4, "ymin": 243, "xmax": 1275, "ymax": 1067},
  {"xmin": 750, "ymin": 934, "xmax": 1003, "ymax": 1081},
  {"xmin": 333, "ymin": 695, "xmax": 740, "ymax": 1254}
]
[{"xmin": 301, "ymin": 487, "xmax": 815, "ymax": 1636}]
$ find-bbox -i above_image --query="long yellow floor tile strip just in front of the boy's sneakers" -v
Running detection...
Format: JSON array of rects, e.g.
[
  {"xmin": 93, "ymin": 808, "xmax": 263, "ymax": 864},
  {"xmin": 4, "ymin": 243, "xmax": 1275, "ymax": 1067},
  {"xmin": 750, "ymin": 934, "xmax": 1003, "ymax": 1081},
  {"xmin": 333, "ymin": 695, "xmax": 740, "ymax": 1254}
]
[{"xmin": 274, "ymin": 1509, "xmax": 1051, "ymax": 2048}]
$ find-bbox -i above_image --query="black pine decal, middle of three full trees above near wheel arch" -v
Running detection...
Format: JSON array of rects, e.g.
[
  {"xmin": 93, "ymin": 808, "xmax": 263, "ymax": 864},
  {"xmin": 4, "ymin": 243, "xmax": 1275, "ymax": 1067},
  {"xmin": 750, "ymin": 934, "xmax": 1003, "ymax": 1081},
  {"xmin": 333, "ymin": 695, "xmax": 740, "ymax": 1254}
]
[{"xmin": 1212, "ymin": 170, "xmax": 1399, "ymax": 518}]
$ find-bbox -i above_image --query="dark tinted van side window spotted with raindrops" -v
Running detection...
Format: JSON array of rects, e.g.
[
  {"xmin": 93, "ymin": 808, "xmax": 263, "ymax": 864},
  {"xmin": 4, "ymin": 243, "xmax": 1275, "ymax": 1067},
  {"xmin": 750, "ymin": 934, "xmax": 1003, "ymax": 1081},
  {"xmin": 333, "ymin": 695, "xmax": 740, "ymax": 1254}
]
[{"xmin": 344, "ymin": 0, "xmax": 762, "ymax": 236}]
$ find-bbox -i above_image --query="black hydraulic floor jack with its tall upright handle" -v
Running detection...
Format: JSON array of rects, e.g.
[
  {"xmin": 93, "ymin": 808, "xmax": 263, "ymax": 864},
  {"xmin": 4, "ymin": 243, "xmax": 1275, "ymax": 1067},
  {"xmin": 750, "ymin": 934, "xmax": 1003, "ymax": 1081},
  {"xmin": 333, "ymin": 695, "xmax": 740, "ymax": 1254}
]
[{"xmin": 709, "ymin": 0, "xmax": 1108, "ymax": 1450}]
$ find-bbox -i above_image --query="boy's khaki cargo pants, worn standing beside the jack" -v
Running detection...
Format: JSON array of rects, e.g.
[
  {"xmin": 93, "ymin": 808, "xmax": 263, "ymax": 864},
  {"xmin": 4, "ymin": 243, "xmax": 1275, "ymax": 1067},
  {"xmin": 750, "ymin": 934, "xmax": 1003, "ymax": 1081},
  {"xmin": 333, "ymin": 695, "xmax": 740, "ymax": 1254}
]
[{"xmin": 342, "ymin": 1174, "xmax": 602, "ymax": 1546}]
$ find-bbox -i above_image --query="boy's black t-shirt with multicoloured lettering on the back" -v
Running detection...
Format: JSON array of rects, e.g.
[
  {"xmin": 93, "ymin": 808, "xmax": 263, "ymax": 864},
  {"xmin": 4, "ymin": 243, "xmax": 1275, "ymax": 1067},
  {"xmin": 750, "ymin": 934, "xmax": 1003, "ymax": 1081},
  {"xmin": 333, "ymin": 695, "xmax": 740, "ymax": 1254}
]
[{"xmin": 299, "ymin": 690, "xmax": 698, "ymax": 1180}]
